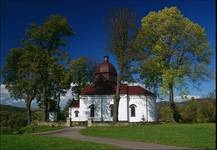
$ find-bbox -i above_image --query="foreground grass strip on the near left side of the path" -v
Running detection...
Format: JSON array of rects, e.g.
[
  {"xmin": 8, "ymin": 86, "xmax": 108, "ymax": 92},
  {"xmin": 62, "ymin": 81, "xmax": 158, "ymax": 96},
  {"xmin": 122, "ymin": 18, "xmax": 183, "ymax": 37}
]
[{"xmin": 0, "ymin": 135, "xmax": 120, "ymax": 150}]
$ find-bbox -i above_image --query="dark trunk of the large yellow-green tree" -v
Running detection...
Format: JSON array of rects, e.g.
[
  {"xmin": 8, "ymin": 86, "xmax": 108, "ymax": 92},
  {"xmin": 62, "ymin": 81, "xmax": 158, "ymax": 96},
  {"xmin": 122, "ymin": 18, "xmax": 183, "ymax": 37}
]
[{"xmin": 169, "ymin": 83, "xmax": 181, "ymax": 122}]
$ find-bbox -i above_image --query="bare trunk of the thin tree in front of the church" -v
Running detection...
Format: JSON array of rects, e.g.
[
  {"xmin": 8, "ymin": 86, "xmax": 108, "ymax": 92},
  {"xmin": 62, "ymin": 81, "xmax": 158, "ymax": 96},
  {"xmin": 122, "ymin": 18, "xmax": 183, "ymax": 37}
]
[{"xmin": 113, "ymin": 77, "xmax": 121, "ymax": 123}]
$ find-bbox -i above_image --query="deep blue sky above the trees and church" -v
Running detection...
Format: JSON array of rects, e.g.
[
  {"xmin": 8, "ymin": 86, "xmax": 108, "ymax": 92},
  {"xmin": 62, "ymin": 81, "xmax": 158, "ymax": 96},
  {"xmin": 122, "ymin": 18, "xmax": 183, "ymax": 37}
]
[{"xmin": 0, "ymin": 0, "xmax": 216, "ymax": 99}]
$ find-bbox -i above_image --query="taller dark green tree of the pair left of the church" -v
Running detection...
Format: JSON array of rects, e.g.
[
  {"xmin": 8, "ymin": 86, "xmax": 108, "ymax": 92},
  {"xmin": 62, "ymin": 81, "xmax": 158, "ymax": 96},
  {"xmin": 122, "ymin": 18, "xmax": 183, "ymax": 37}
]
[{"xmin": 23, "ymin": 15, "xmax": 73, "ymax": 121}]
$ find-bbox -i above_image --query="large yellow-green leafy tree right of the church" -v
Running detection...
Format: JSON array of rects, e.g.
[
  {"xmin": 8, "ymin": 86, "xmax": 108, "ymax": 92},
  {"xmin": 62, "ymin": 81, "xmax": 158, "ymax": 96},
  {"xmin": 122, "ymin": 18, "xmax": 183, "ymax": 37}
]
[{"xmin": 137, "ymin": 7, "xmax": 211, "ymax": 121}]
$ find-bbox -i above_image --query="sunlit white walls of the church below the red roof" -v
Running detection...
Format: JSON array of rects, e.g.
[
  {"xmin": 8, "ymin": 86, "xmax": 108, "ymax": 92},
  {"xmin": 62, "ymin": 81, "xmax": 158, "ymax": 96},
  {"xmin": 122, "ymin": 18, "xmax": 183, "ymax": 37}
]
[{"xmin": 69, "ymin": 95, "xmax": 157, "ymax": 122}]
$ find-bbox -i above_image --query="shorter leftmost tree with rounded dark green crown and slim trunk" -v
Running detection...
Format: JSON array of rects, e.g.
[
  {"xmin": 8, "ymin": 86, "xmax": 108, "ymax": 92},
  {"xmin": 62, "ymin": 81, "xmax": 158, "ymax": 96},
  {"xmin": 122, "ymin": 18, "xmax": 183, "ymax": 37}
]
[{"xmin": 3, "ymin": 46, "xmax": 39, "ymax": 124}]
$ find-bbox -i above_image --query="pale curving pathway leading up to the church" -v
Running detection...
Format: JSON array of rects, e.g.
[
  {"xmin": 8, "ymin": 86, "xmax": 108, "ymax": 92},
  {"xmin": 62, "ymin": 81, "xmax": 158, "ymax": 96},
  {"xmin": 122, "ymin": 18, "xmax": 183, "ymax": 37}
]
[{"xmin": 36, "ymin": 127, "xmax": 190, "ymax": 150}]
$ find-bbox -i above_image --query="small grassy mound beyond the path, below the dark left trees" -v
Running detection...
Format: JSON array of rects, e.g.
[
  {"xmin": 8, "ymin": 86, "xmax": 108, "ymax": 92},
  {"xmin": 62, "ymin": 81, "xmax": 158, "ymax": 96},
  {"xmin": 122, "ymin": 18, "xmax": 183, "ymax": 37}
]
[{"xmin": 17, "ymin": 125, "xmax": 64, "ymax": 134}]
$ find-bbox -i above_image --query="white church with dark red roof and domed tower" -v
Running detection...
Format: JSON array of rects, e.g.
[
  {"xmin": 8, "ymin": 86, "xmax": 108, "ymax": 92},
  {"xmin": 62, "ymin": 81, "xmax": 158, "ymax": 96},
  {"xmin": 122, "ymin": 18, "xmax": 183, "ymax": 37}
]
[{"xmin": 69, "ymin": 56, "xmax": 157, "ymax": 122}]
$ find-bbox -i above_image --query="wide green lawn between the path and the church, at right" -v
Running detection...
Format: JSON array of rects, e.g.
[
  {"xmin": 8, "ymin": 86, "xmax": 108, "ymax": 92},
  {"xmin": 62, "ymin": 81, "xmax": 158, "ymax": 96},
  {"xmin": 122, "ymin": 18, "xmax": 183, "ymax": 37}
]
[{"xmin": 81, "ymin": 123, "xmax": 216, "ymax": 149}]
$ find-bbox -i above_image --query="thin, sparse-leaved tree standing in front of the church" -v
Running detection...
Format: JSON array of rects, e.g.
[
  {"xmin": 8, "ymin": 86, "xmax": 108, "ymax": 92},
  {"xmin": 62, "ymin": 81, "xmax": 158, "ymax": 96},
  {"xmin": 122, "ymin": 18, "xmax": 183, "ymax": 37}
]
[{"xmin": 109, "ymin": 8, "xmax": 137, "ymax": 122}]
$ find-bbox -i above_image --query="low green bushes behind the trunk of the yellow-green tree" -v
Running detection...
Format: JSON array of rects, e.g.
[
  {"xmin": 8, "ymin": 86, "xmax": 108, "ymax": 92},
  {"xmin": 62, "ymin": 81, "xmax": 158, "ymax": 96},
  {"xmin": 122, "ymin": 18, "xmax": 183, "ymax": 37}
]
[{"xmin": 158, "ymin": 99, "xmax": 216, "ymax": 123}]
